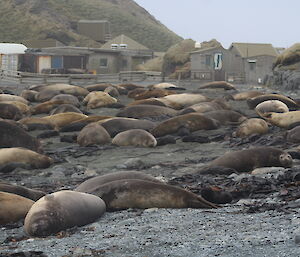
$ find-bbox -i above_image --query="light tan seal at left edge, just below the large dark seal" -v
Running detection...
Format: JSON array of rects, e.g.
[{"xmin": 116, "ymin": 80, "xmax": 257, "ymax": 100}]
[{"xmin": 0, "ymin": 147, "xmax": 53, "ymax": 169}]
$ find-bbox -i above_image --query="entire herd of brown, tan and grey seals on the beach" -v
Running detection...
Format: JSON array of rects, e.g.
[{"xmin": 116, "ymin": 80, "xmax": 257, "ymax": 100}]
[{"xmin": 0, "ymin": 81, "xmax": 300, "ymax": 237}]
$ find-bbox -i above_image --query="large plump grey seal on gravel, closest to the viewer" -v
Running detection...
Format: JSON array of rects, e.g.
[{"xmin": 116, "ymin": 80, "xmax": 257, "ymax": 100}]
[{"xmin": 24, "ymin": 190, "xmax": 106, "ymax": 237}]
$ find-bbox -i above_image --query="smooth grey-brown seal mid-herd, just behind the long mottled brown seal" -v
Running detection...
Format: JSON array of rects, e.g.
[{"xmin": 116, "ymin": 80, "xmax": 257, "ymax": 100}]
[{"xmin": 116, "ymin": 104, "xmax": 177, "ymax": 119}]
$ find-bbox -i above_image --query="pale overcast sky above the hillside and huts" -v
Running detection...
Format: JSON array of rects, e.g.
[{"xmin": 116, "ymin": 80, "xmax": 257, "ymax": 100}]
[{"xmin": 135, "ymin": 0, "xmax": 300, "ymax": 48}]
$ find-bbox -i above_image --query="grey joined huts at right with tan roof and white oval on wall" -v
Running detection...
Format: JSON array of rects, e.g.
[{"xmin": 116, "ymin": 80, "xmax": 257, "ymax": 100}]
[{"xmin": 191, "ymin": 43, "xmax": 278, "ymax": 83}]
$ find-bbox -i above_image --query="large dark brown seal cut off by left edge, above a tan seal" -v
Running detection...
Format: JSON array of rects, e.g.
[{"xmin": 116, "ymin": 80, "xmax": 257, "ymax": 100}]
[{"xmin": 0, "ymin": 120, "xmax": 42, "ymax": 152}]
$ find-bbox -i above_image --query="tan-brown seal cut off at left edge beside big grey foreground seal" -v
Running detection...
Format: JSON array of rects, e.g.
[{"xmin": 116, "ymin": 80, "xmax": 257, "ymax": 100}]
[{"xmin": 0, "ymin": 191, "xmax": 34, "ymax": 225}]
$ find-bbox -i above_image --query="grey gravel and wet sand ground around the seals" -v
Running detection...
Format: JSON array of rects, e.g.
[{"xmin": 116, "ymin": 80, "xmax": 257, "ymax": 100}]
[{"xmin": 0, "ymin": 79, "xmax": 300, "ymax": 257}]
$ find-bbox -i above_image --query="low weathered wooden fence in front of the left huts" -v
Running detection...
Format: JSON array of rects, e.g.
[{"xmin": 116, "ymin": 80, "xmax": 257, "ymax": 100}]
[{"xmin": 0, "ymin": 69, "xmax": 162, "ymax": 85}]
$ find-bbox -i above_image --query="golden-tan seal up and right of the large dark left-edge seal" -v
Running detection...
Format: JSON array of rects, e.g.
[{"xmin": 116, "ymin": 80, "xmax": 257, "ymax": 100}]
[{"xmin": 42, "ymin": 112, "xmax": 88, "ymax": 130}]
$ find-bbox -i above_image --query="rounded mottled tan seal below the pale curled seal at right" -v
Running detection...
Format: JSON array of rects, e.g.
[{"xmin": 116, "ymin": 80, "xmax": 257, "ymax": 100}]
[{"xmin": 234, "ymin": 118, "xmax": 269, "ymax": 138}]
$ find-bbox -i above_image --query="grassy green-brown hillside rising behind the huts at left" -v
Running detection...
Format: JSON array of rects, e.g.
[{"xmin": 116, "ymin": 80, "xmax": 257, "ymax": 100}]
[{"xmin": 0, "ymin": 0, "xmax": 182, "ymax": 51}]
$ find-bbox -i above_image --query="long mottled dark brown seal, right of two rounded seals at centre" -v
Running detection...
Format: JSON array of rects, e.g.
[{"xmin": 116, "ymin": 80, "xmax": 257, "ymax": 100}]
[{"xmin": 150, "ymin": 113, "xmax": 220, "ymax": 137}]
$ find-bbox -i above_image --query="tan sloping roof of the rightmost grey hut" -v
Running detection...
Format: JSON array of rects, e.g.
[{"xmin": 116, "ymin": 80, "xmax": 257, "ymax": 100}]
[{"xmin": 229, "ymin": 43, "xmax": 278, "ymax": 58}]
